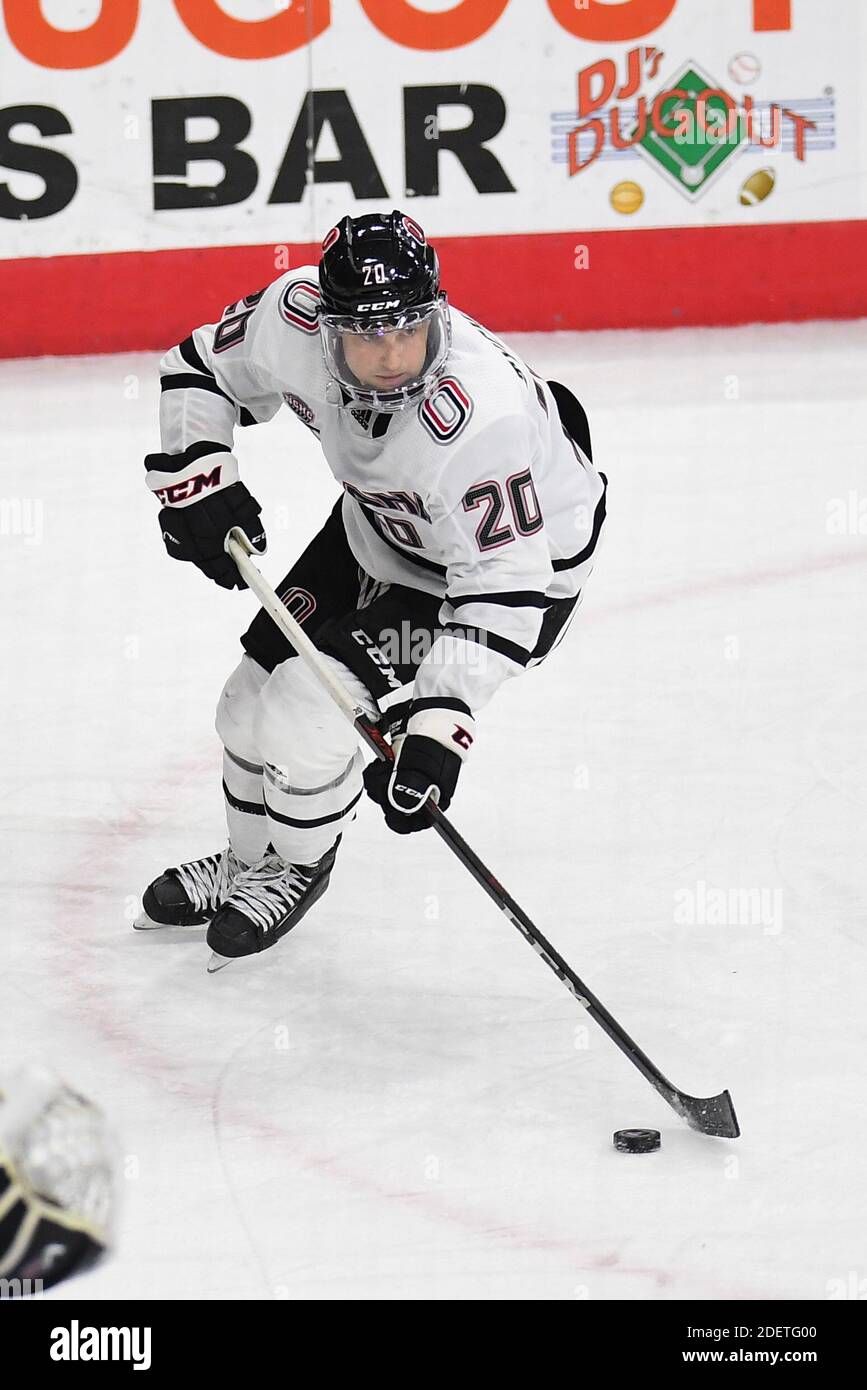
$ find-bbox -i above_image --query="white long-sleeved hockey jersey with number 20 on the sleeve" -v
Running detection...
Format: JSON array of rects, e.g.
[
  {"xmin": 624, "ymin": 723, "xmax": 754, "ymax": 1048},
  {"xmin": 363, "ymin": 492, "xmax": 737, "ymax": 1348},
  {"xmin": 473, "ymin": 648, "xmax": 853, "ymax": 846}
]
[{"xmin": 155, "ymin": 265, "xmax": 604, "ymax": 710}]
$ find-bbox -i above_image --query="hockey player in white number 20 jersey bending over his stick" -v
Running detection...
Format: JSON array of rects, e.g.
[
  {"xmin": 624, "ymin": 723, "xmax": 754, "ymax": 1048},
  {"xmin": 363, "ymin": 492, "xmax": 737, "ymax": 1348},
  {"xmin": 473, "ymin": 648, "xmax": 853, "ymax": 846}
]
[{"xmin": 139, "ymin": 211, "xmax": 606, "ymax": 958}]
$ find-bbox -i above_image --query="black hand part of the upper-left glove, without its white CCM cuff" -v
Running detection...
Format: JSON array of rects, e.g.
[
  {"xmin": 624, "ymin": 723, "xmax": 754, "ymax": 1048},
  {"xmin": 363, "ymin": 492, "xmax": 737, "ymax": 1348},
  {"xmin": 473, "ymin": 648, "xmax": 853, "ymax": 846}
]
[{"xmin": 160, "ymin": 482, "xmax": 267, "ymax": 589}]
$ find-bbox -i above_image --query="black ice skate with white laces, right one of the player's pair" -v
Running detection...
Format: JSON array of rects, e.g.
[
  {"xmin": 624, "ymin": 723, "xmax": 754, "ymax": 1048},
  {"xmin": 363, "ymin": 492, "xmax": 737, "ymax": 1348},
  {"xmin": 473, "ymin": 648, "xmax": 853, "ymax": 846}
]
[{"xmin": 207, "ymin": 837, "xmax": 340, "ymax": 974}]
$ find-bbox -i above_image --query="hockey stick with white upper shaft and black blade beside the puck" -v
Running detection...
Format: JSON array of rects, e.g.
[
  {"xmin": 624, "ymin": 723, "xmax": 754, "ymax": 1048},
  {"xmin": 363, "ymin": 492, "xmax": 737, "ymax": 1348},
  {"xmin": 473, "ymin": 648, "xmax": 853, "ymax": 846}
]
[{"xmin": 225, "ymin": 527, "xmax": 741, "ymax": 1138}]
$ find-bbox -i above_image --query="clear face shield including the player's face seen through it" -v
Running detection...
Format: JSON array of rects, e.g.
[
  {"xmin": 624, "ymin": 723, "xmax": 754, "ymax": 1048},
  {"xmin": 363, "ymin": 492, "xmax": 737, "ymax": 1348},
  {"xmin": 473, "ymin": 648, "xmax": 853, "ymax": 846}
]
[{"xmin": 320, "ymin": 295, "xmax": 452, "ymax": 411}]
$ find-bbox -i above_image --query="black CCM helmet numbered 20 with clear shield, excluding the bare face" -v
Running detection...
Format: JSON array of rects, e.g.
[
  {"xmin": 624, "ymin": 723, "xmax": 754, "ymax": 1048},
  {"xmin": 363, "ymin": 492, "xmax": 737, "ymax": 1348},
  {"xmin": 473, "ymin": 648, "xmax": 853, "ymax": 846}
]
[{"xmin": 320, "ymin": 209, "xmax": 452, "ymax": 411}]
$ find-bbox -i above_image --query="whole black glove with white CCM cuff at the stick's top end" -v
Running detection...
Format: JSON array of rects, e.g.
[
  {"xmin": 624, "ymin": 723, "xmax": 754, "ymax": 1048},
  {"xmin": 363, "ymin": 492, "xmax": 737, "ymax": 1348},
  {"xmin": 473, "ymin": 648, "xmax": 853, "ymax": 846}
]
[{"xmin": 145, "ymin": 443, "xmax": 267, "ymax": 589}]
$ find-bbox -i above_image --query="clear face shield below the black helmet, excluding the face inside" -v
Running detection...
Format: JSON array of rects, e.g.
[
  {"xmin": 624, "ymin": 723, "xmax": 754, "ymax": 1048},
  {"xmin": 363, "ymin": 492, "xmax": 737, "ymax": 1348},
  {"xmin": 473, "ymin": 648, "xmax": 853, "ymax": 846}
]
[{"xmin": 320, "ymin": 295, "xmax": 452, "ymax": 414}]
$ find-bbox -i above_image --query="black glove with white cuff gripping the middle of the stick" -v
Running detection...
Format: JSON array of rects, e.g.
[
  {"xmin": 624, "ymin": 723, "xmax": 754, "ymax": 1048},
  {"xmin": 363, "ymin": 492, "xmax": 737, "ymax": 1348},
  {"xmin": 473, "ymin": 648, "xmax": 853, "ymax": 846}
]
[{"xmin": 364, "ymin": 701, "xmax": 474, "ymax": 835}]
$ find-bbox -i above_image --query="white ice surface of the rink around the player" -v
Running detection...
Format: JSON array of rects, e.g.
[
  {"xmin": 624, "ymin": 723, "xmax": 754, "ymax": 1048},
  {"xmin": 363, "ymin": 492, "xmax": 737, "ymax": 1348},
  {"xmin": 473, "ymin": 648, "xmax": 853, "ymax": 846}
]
[{"xmin": 0, "ymin": 322, "xmax": 867, "ymax": 1300}]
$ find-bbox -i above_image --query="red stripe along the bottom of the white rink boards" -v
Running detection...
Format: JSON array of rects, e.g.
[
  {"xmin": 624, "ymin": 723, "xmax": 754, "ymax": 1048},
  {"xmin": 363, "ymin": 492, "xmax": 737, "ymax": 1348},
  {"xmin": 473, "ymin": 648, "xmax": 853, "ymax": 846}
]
[{"xmin": 0, "ymin": 221, "xmax": 867, "ymax": 357}]
